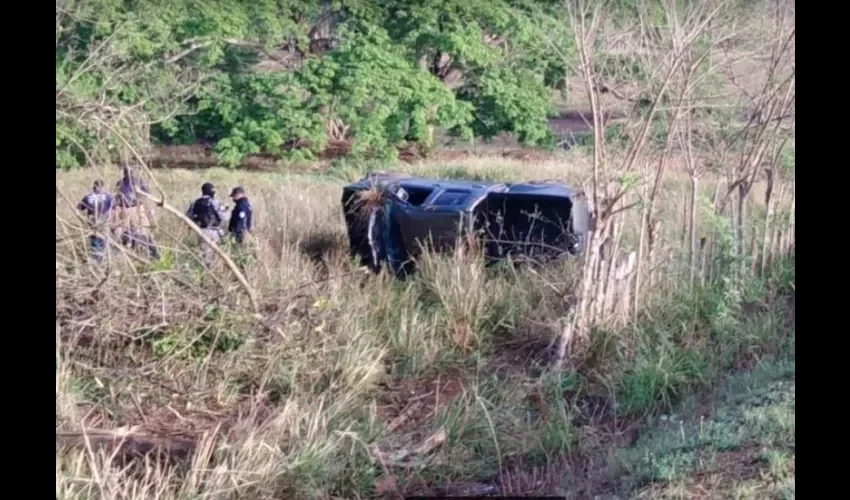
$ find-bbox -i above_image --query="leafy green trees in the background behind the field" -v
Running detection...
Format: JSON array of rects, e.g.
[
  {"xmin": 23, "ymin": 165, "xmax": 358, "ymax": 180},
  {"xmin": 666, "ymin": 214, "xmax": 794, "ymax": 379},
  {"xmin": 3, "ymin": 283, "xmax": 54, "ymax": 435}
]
[{"xmin": 56, "ymin": 0, "xmax": 572, "ymax": 168}]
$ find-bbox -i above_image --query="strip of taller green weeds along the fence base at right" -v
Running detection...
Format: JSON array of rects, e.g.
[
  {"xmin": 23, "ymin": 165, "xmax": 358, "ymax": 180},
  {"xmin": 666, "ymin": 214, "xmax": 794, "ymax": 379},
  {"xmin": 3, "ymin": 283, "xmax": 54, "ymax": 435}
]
[{"xmin": 615, "ymin": 254, "xmax": 795, "ymax": 415}]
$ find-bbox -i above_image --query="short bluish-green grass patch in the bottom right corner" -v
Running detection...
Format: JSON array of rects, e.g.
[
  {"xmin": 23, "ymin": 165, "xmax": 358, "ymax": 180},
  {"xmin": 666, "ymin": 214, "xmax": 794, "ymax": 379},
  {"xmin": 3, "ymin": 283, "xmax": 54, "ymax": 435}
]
[{"xmin": 616, "ymin": 359, "xmax": 796, "ymax": 499}]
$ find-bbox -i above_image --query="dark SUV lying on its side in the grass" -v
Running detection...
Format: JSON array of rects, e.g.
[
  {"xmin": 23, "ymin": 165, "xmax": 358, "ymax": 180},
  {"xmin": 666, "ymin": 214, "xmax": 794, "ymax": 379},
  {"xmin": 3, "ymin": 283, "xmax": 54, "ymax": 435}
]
[{"xmin": 342, "ymin": 172, "xmax": 589, "ymax": 276}]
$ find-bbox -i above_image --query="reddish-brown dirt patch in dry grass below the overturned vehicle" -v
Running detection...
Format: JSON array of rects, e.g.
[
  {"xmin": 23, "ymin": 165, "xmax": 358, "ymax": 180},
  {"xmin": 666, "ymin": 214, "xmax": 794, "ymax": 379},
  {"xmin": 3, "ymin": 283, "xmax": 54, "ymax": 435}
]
[{"xmin": 378, "ymin": 373, "xmax": 465, "ymax": 433}]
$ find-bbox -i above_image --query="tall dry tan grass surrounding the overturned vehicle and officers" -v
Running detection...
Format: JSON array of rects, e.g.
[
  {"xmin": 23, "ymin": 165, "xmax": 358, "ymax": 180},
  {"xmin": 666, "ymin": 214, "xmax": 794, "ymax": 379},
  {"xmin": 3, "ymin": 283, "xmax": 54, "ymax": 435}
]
[{"xmin": 56, "ymin": 153, "xmax": 792, "ymax": 499}]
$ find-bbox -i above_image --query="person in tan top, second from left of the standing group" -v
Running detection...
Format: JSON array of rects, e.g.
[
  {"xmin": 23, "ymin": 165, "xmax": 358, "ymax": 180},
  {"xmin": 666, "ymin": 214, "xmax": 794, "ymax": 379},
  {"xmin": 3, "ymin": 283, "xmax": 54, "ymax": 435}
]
[{"xmin": 115, "ymin": 165, "xmax": 159, "ymax": 260}]
